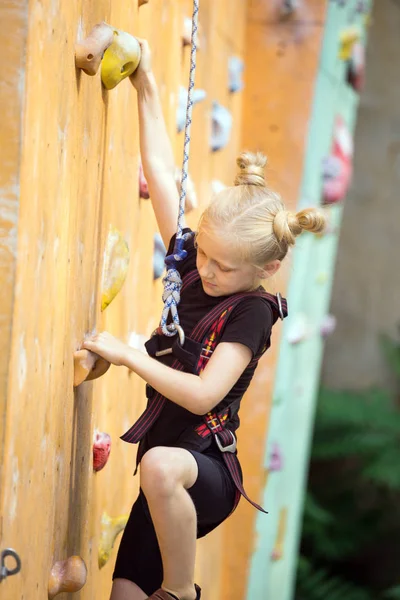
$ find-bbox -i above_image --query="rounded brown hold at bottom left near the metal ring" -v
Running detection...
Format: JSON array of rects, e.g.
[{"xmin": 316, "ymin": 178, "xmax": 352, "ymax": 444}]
[{"xmin": 48, "ymin": 556, "xmax": 87, "ymax": 600}]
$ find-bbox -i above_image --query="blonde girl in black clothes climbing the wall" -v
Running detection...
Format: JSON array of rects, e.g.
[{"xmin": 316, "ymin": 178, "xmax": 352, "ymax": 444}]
[{"xmin": 84, "ymin": 40, "xmax": 324, "ymax": 600}]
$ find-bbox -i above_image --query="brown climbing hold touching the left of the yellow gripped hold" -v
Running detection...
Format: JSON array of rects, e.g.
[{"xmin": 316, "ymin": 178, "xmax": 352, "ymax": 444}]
[{"xmin": 75, "ymin": 21, "xmax": 114, "ymax": 75}]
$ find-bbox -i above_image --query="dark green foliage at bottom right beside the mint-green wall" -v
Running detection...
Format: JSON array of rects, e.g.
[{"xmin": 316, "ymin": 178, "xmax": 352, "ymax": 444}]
[{"xmin": 295, "ymin": 336, "xmax": 400, "ymax": 600}]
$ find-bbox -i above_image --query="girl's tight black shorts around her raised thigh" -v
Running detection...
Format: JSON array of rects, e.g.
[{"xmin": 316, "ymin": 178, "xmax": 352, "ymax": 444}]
[{"xmin": 113, "ymin": 450, "xmax": 238, "ymax": 596}]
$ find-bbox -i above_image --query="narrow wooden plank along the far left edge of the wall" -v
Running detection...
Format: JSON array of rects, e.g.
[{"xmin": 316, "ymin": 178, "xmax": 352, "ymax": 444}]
[{"xmin": 0, "ymin": 0, "xmax": 28, "ymax": 549}]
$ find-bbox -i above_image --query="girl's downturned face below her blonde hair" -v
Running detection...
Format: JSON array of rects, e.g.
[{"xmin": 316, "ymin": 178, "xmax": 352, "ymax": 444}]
[{"xmin": 196, "ymin": 229, "xmax": 262, "ymax": 296}]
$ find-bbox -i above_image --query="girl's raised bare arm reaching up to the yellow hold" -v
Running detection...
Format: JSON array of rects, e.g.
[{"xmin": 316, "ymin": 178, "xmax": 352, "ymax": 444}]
[{"xmin": 131, "ymin": 40, "xmax": 179, "ymax": 248}]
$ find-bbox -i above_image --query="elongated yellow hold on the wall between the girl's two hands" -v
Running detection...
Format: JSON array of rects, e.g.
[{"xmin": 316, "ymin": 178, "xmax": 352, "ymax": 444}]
[{"xmin": 101, "ymin": 227, "xmax": 129, "ymax": 311}]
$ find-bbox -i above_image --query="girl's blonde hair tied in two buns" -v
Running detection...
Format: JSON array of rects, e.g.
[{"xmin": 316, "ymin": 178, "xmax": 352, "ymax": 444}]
[{"xmin": 198, "ymin": 152, "xmax": 326, "ymax": 267}]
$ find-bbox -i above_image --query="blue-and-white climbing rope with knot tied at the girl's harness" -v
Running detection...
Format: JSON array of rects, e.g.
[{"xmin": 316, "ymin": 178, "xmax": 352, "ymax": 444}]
[{"xmin": 160, "ymin": 0, "xmax": 199, "ymax": 343}]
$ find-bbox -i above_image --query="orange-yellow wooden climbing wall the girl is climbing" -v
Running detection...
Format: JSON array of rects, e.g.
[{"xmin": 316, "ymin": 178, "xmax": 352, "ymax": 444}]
[{"xmin": 0, "ymin": 0, "xmax": 246, "ymax": 600}]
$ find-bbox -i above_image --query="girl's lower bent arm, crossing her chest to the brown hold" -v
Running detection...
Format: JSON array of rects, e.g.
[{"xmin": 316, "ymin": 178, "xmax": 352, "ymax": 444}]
[{"xmin": 83, "ymin": 332, "xmax": 252, "ymax": 415}]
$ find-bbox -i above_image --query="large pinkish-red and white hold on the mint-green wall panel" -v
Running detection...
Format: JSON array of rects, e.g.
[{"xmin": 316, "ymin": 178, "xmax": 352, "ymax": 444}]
[{"xmin": 322, "ymin": 117, "xmax": 353, "ymax": 204}]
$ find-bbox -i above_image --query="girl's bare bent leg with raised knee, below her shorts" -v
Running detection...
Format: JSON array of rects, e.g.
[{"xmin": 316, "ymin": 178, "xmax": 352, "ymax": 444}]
[{"xmin": 140, "ymin": 446, "xmax": 198, "ymax": 600}]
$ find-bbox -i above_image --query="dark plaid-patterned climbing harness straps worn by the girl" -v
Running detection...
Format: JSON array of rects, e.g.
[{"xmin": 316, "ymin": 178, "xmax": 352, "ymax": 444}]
[{"xmin": 121, "ymin": 269, "xmax": 287, "ymax": 512}]
